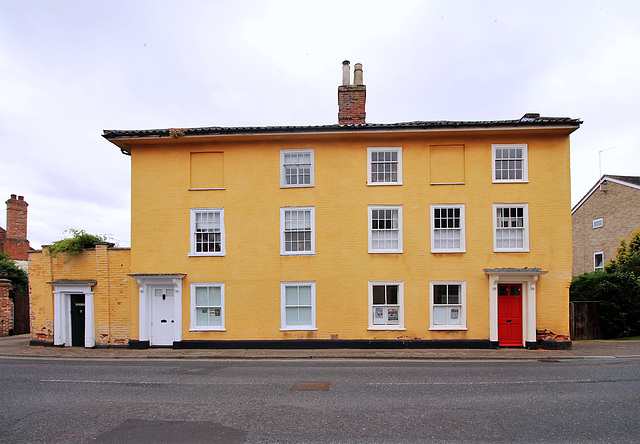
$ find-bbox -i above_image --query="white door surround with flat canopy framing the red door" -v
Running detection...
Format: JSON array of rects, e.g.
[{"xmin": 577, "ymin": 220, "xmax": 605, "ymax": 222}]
[{"xmin": 484, "ymin": 268, "xmax": 548, "ymax": 347}]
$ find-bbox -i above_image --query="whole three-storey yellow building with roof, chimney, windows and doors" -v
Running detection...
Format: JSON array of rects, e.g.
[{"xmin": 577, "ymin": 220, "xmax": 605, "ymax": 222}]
[{"xmin": 28, "ymin": 64, "xmax": 581, "ymax": 347}]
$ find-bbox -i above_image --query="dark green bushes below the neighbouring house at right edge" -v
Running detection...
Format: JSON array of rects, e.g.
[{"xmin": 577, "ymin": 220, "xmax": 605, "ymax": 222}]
[{"xmin": 569, "ymin": 230, "xmax": 640, "ymax": 338}]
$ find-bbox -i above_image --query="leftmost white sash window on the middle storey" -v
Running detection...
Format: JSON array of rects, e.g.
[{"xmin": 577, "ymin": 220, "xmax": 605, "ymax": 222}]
[{"xmin": 189, "ymin": 208, "xmax": 225, "ymax": 256}]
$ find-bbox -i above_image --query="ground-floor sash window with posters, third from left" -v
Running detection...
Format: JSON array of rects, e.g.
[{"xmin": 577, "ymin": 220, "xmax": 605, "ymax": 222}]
[{"xmin": 369, "ymin": 281, "xmax": 404, "ymax": 330}]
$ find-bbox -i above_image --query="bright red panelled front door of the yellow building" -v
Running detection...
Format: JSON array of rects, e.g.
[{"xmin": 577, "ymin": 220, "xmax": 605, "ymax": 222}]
[{"xmin": 498, "ymin": 284, "xmax": 522, "ymax": 347}]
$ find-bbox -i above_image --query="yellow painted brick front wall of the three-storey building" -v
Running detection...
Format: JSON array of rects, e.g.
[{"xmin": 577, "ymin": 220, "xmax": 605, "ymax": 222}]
[{"xmin": 127, "ymin": 130, "xmax": 571, "ymax": 340}]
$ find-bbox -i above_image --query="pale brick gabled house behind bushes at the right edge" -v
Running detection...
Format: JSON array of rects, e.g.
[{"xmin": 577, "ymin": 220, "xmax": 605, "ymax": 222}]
[{"xmin": 571, "ymin": 174, "xmax": 640, "ymax": 276}]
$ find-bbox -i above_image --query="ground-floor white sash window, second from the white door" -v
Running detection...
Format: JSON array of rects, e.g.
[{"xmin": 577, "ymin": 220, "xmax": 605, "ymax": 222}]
[{"xmin": 281, "ymin": 282, "xmax": 316, "ymax": 330}]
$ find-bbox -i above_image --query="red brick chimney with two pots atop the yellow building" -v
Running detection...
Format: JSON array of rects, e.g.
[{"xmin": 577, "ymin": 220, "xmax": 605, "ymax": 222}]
[{"xmin": 338, "ymin": 60, "xmax": 367, "ymax": 125}]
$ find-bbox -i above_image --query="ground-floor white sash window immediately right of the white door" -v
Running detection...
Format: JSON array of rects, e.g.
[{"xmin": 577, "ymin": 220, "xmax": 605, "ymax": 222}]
[{"xmin": 190, "ymin": 282, "xmax": 225, "ymax": 331}]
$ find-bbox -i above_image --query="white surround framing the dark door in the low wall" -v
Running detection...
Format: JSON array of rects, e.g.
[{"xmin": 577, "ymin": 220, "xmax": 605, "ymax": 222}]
[{"xmin": 47, "ymin": 281, "xmax": 97, "ymax": 347}]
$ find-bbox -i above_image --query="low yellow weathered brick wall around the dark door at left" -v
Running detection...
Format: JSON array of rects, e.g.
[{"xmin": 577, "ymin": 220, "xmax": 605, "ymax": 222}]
[{"xmin": 29, "ymin": 244, "xmax": 132, "ymax": 346}]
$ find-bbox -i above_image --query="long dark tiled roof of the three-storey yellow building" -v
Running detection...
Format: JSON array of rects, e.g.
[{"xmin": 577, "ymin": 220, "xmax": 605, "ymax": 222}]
[{"xmin": 102, "ymin": 114, "xmax": 582, "ymax": 140}]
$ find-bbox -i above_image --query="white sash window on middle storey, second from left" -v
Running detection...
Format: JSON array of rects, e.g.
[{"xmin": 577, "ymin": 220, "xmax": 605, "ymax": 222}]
[{"xmin": 280, "ymin": 207, "xmax": 316, "ymax": 255}]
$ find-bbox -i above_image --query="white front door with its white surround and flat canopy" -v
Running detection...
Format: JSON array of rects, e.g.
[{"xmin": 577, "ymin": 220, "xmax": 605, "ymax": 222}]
[{"xmin": 129, "ymin": 274, "xmax": 186, "ymax": 345}]
